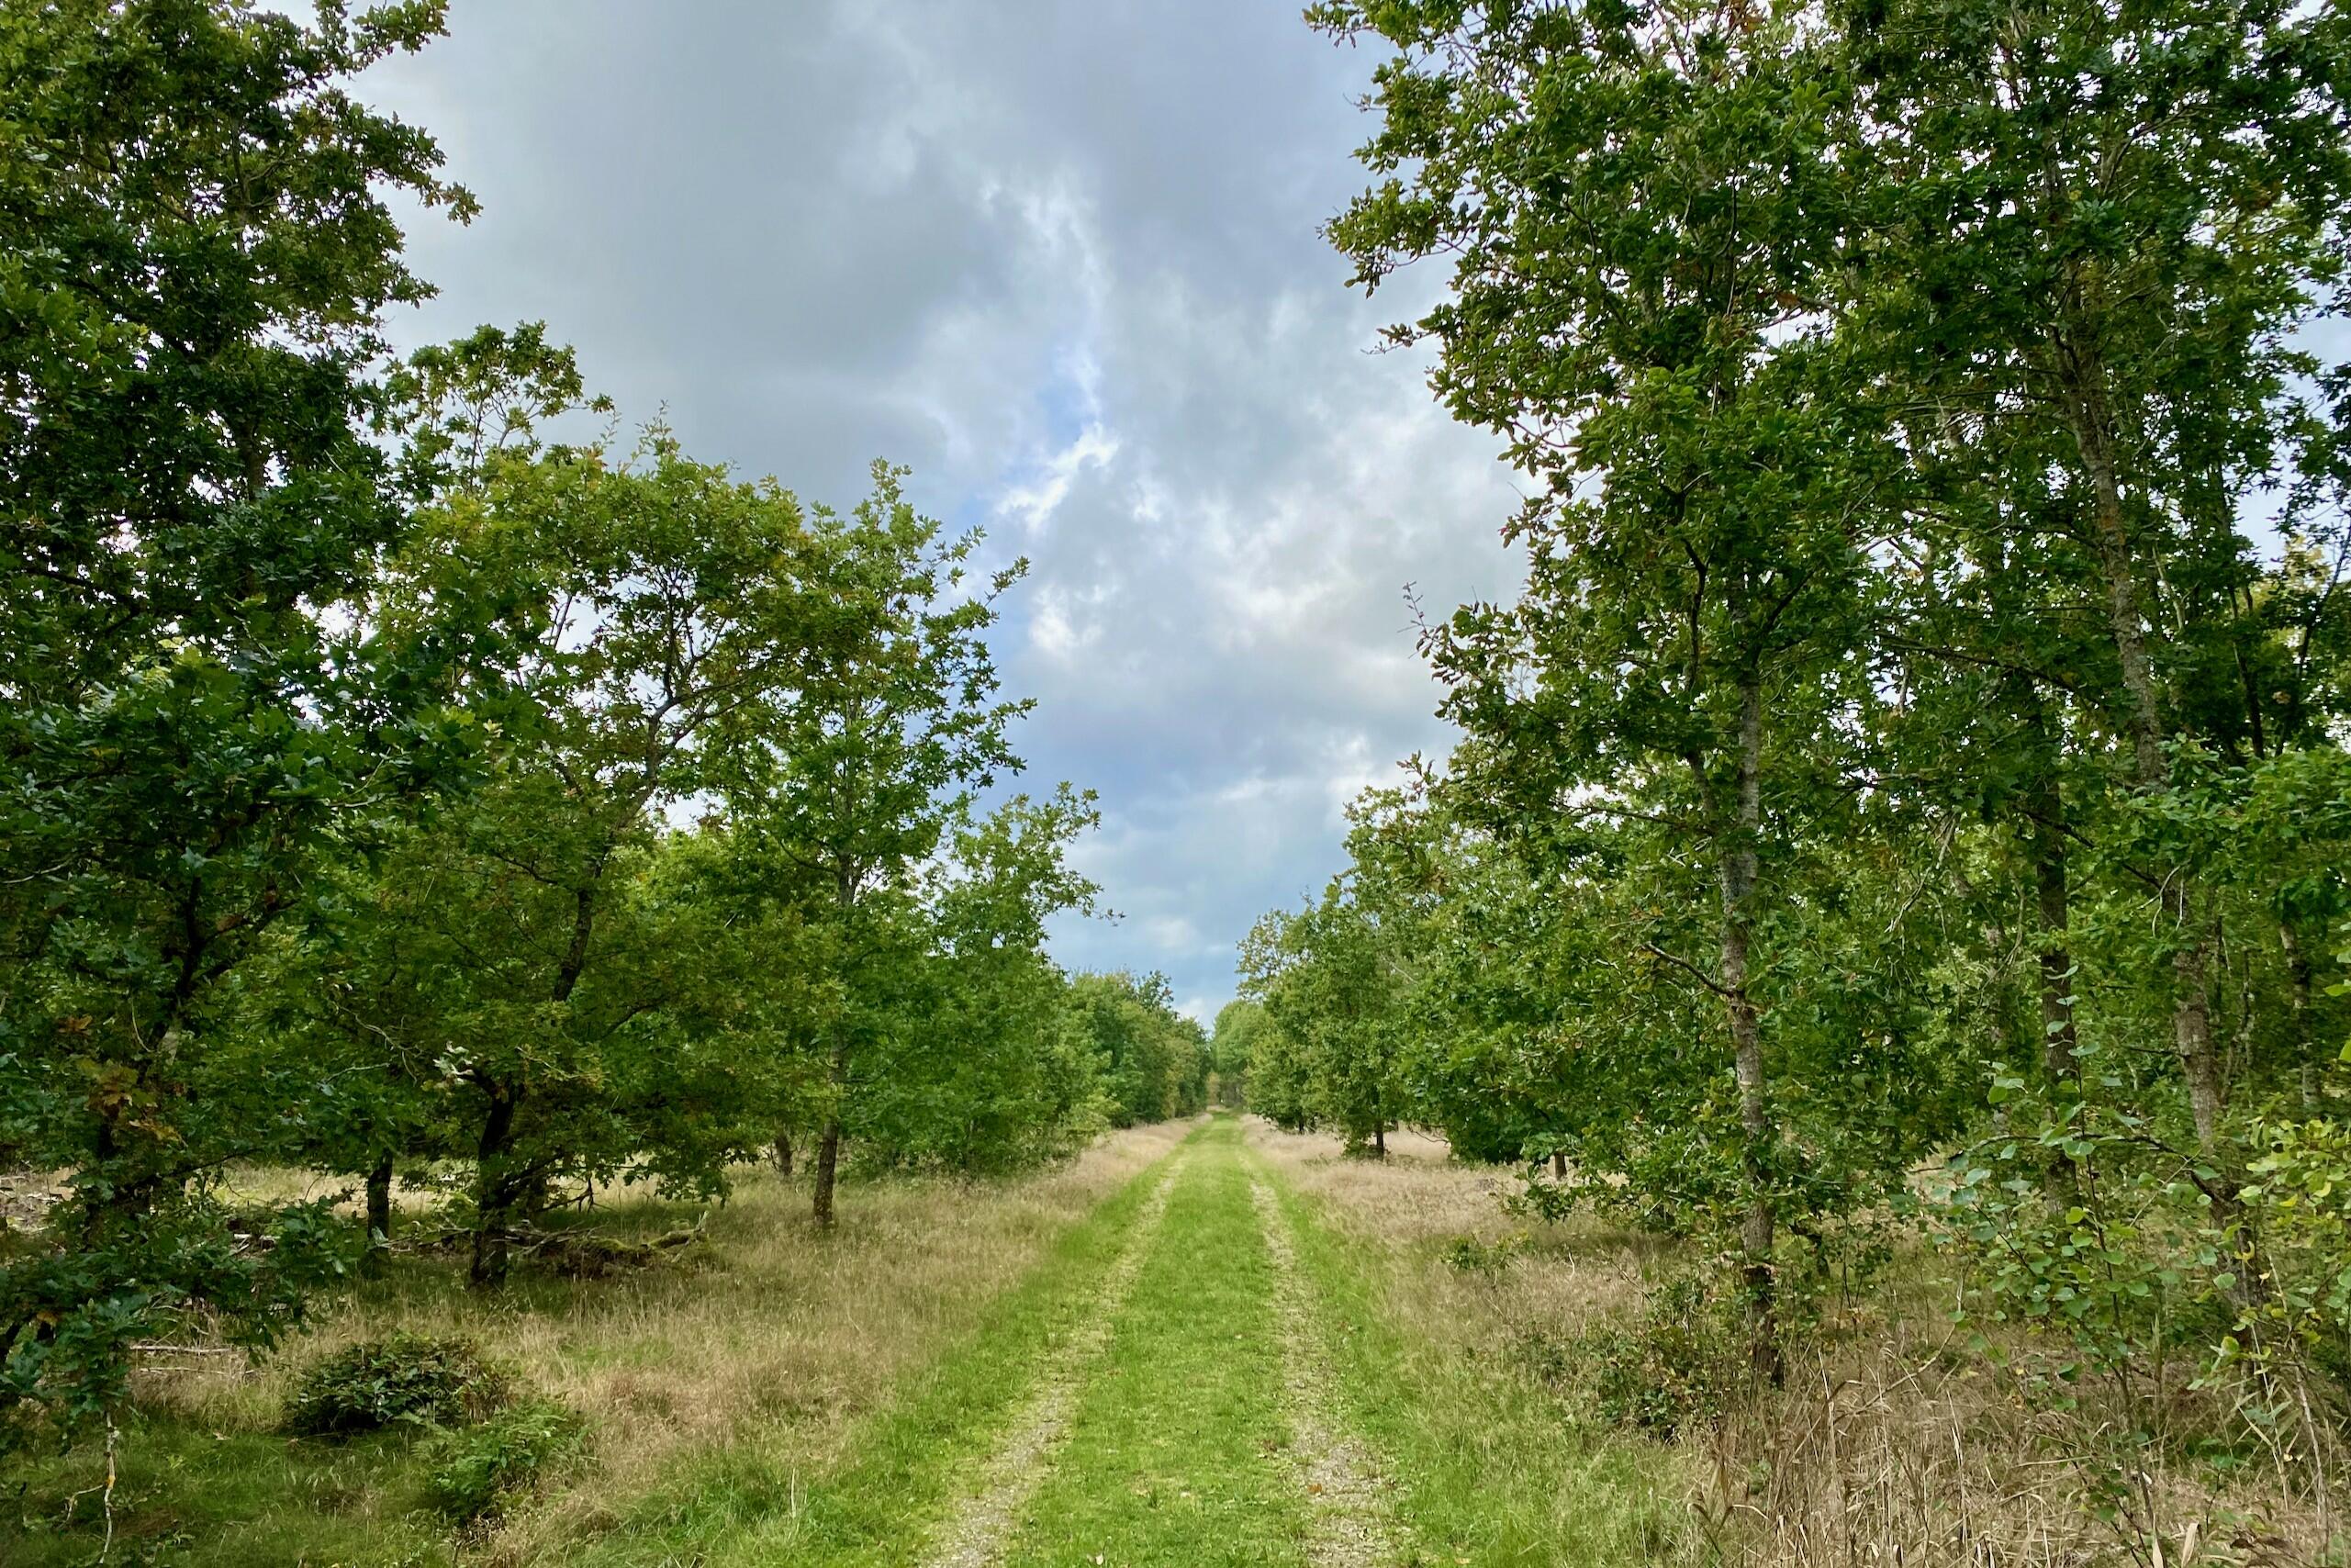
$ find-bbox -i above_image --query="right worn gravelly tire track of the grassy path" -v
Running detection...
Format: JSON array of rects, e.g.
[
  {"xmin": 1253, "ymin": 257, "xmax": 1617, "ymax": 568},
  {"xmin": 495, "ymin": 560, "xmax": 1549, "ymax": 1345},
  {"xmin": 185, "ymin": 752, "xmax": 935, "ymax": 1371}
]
[{"xmin": 1248, "ymin": 1170, "xmax": 1408, "ymax": 1568}]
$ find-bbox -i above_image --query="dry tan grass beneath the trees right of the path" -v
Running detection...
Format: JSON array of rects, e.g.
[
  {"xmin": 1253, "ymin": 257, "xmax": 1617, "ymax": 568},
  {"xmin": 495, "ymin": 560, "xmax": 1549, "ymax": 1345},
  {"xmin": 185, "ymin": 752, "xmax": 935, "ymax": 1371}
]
[{"xmin": 1248, "ymin": 1119, "xmax": 2344, "ymax": 1568}]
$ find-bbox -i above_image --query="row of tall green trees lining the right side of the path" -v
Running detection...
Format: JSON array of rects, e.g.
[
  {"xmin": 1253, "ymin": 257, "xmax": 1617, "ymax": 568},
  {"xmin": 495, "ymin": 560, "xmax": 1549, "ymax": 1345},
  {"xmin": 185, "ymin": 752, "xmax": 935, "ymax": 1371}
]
[{"xmin": 1250, "ymin": 0, "xmax": 2351, "ymax": 1448}]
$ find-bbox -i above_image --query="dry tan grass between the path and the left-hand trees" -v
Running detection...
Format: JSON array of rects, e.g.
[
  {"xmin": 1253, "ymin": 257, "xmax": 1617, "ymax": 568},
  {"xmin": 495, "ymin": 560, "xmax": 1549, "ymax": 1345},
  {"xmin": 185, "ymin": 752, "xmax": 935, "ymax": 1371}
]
[{"xmin": 139, "ymin": 1124, "xmax": 1192, "ymax": 1561}]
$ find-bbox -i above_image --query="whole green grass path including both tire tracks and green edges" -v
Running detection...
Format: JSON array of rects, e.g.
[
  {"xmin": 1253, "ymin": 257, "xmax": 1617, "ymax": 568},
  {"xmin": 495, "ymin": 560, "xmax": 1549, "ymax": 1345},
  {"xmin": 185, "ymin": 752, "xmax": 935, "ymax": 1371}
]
[{"xmin": 588, "ymin": 1116, "xmax": 1688, "ymax": 1568}]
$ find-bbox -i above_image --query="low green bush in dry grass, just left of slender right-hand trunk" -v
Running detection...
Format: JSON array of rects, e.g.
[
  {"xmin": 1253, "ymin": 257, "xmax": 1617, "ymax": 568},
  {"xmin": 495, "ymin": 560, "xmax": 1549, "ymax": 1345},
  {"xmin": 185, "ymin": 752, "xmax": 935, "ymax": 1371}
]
[{"xmin": 1573, "ymin": 1274, "xmax": 1742, "ymax": 1441}]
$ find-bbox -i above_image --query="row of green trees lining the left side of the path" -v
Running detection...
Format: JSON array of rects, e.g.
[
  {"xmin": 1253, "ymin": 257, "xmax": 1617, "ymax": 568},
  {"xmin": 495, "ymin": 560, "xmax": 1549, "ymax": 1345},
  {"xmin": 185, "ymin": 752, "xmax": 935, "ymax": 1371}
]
[{"xmin": 0, "ymin": 0, "xmax": 1206, "ymax": 1466}]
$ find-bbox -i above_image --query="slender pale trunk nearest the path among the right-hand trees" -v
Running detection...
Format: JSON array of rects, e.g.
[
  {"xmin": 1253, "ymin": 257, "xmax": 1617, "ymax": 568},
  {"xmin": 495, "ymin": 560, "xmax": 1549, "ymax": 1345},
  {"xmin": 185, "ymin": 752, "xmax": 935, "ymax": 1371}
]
[{"xmin": 1721, "ymin": 675, "xmax": 1782, "ymax": 1384}]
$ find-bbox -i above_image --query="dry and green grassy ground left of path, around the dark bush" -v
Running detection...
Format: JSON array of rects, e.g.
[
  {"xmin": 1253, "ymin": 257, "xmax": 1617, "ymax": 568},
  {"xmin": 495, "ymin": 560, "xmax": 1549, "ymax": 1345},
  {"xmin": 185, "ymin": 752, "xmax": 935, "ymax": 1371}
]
[{"xmin": 0, "ymin": 1126, "xmax": 1190, "ymax": 1568}]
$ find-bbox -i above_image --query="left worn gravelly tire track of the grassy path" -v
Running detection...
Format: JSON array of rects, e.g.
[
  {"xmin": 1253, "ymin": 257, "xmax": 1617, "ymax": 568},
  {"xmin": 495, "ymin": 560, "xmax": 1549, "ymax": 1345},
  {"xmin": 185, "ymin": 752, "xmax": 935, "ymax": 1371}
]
[{"xmin": 922, "ymin": 1148, "xmax": 1192, "ymax": 1568}]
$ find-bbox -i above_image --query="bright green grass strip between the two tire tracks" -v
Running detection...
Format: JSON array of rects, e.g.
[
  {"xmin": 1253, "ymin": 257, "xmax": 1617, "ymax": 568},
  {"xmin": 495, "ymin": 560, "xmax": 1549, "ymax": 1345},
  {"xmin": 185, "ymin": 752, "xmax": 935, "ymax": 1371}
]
[{"xmin": 1006, "ymin": 1116, "xmax": 1304, "ymax": 1568}]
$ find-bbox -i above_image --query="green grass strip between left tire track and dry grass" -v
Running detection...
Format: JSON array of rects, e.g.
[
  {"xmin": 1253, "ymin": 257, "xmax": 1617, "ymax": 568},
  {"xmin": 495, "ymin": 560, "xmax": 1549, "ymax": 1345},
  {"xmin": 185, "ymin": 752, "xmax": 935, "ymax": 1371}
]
[{"xmin": 566, "ymin": 1133, "xmax": 1199, "ymax": 1568}]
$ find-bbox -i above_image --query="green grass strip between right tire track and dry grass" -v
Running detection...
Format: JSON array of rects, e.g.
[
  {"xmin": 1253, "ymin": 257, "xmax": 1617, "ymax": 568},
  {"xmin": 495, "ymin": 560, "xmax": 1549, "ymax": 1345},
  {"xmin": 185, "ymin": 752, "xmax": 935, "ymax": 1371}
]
[{"xmin": 1250, "ymin": 1154, "xmax": 1709, "ymax": 1568}]
